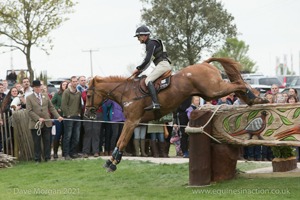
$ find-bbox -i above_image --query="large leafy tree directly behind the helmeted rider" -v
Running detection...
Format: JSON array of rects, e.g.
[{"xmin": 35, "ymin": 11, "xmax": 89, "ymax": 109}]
[{"xmin": 141, "ymin": 0, "xmax": 236, "ymax": 68}]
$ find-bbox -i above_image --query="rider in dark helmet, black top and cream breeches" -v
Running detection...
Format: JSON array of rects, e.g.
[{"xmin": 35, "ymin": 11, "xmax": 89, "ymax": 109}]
[{"xmin": 133, "ymin": 26, "xmax": 171, "ymax": 110}]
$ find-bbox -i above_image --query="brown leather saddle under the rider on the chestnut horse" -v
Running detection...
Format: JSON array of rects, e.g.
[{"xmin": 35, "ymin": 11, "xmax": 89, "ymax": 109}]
[{"xmin": 137, "ymin": 70, "xmax": 172, "ymax": 94}]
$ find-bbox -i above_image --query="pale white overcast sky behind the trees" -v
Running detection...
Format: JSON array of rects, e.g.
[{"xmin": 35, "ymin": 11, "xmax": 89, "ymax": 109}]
[{"xmin": 0, "ymin": 0, "xmax": 300, "ymax": 79}]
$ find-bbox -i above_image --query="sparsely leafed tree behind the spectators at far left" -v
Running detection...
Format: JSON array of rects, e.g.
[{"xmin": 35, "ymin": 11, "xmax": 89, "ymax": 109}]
[{"xmin": 0, "ymin": 0, "xmax": 75, "ymax": 81}]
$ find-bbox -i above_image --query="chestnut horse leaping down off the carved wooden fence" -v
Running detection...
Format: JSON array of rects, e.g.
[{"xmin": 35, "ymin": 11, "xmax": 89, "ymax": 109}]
[{"xmin": 85, "ymin": 58, "xmax": 265, "ymax": 172}]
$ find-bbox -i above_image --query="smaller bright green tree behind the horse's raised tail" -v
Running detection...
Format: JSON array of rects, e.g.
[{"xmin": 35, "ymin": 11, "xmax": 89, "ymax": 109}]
[{"xmin": 214, "ymin": 38, "xmax": 257, "ymax": 73}]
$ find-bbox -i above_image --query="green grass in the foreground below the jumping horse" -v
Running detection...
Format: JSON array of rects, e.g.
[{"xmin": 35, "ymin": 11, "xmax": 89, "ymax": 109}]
[{"xmin": 0, "ymin": 159, "xmax": 300, "ymax": 200}]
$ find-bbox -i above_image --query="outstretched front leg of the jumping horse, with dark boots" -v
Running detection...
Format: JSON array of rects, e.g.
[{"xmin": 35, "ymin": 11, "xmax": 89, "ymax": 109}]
[{"xmin": 103, "ymin": 121, "xmax": 138, "ymax": 172}]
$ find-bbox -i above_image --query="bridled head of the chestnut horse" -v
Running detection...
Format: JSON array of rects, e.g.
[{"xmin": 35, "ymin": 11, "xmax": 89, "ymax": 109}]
[{"xmin": 84, "ymin": 78, "xmax": 104, "ymax": 119}]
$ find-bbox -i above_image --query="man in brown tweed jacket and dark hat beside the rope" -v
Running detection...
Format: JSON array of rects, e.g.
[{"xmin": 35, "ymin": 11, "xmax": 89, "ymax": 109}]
[{"xmin": 26, "ymin": 80, "xmax": 63, "ymax": 162}]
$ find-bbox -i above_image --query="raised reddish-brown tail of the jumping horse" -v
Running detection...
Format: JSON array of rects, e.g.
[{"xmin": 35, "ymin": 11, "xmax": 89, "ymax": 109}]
[{"xmin": 204, "ymin": 58, "xmax": 243, "ymax": 82}]
